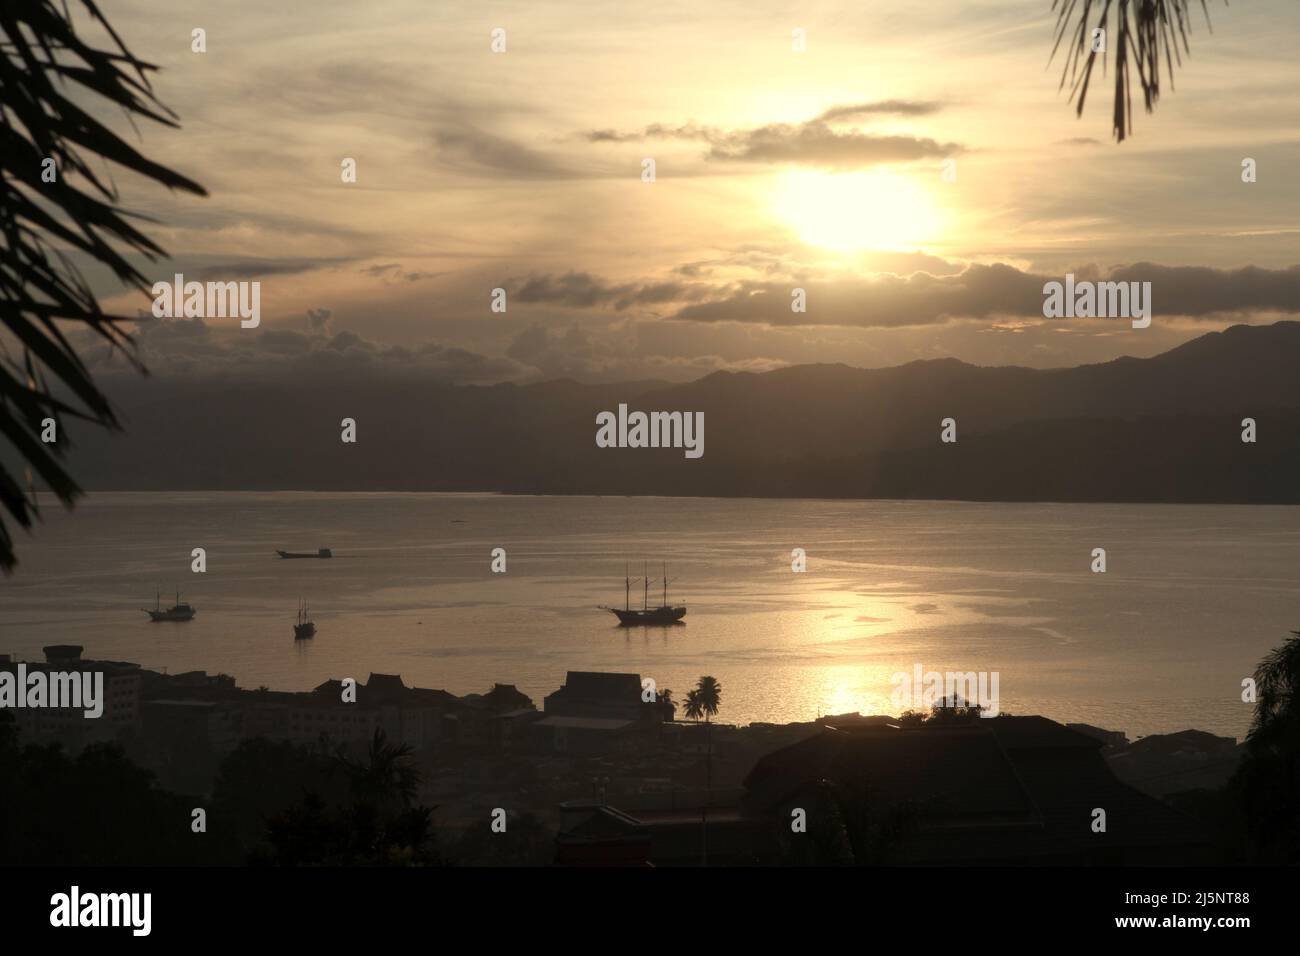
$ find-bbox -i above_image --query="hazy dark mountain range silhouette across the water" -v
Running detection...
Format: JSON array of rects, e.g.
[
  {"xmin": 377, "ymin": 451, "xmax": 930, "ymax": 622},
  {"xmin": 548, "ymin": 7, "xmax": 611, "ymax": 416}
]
[{"xmin": 48, "ymin": 323, "xmax": 1300, "ymax": 502}]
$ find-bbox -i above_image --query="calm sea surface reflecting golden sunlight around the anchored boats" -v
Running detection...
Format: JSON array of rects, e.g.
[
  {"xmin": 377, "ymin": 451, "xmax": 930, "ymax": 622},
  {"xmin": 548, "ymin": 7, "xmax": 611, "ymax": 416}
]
[{"xmin": 0, "ymin": 493, "xmax": 1300, "ymax": 737}]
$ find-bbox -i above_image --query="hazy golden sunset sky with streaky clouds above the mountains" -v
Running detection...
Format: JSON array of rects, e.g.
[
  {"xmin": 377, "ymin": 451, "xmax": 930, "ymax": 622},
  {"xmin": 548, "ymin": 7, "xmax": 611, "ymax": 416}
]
[{"xmin": 68, "ymin": 0, "xmax": 1300, "ymax": 384}]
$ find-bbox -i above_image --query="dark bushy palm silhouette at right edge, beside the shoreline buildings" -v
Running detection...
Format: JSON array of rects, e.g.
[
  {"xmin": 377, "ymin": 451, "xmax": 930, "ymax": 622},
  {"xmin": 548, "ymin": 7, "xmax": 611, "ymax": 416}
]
[{"xmin": 1232, "ymin": 631, "xmax": 1300, "ymax": 864}]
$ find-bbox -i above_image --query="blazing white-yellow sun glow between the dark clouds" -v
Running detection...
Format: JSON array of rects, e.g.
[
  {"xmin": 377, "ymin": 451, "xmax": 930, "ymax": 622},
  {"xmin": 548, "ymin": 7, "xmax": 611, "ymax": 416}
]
[{"xmin": 775, "ymin": 170, "xmax": 944, "ymax": 252}]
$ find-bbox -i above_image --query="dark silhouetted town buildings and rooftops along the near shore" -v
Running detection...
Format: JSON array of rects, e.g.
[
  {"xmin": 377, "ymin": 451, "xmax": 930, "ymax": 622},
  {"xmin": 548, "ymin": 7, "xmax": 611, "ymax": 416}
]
[{"xmin": 0, "ymin": 645, "xmax": 1236, "ymax": 866}]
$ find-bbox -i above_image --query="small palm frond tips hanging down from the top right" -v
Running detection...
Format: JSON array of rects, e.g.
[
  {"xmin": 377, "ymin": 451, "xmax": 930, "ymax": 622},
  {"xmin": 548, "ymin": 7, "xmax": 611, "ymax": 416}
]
[{"xmin": 1052, "ymin": 0, "xmax": 1226, "ymax": 142}]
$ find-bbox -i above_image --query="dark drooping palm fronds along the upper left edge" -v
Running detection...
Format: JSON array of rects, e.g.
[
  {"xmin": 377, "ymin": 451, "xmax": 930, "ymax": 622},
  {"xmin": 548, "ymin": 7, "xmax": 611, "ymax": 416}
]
[{"xmin": 0, "ymin": 0, "xmax": 205, "ymax": 574}]
